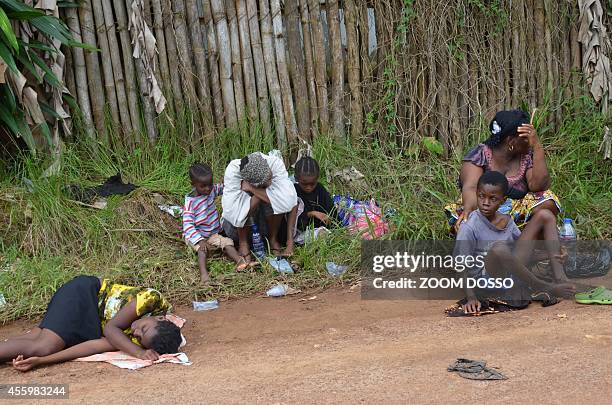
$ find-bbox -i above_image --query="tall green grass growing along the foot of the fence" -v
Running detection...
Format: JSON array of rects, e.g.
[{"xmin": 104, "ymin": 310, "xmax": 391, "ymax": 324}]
[{"xmin": 0, "ymin": 98, "xmax": 612, "ymax": 321}]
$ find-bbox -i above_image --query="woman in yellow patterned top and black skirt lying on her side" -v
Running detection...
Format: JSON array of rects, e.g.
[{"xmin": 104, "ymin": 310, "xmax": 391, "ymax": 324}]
[{"xmin": 0, "ymin": 276, "xmax": 182, "ymax": 371}]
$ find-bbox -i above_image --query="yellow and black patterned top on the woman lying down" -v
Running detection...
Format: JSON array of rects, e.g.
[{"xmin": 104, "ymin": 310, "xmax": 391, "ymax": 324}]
[{"xmin": 98, "ymin": 279, "xmax": 172, "ymax": 345}]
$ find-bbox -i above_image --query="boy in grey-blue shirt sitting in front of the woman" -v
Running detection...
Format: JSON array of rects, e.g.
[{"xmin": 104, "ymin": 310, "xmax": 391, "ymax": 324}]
[{"xmin": 454, "ymin": 171, "xmax": 574, "ymax": 313}]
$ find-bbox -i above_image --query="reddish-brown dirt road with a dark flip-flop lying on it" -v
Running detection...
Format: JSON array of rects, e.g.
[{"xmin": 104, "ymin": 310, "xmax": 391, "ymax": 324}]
[{"xmin": 0, "ymin": 289, "xmax": 612, "ymax": 404}]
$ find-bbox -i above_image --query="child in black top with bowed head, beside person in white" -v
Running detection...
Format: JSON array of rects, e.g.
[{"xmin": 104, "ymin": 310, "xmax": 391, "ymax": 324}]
[{"xmin": 295, "ymin": 156, "xmax": 335, "ymax": 231}]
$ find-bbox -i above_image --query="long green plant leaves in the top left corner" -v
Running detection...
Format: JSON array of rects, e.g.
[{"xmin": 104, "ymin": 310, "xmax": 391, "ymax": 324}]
[{"xmin": 0, "ymin": 0, "xmax": 85, "ymax": 153}]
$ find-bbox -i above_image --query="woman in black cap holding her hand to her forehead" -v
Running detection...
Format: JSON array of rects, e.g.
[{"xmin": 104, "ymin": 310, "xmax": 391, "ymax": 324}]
[{"xmin": 445, "ymin": 110, "xmax": 561, "ymax": 233}]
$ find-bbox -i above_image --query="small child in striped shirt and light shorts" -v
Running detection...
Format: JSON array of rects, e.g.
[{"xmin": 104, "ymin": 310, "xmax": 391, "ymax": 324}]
[{"xmin": 183, "ymin": 163, "xmax": 249, "ymax": 283}]
